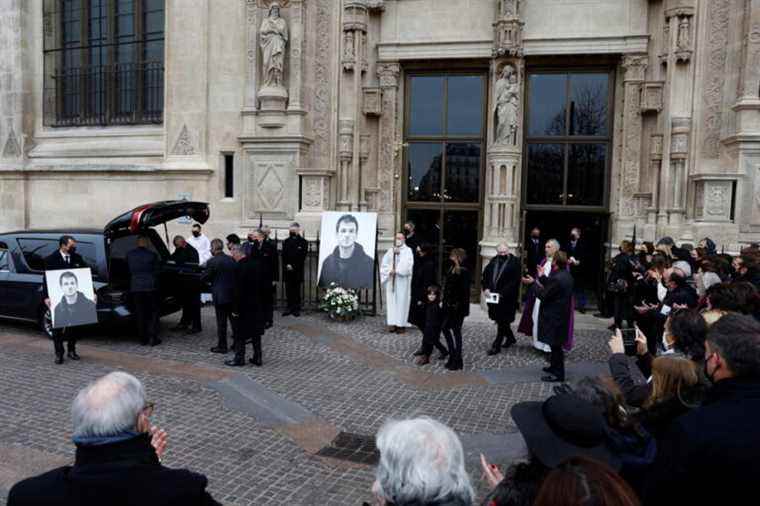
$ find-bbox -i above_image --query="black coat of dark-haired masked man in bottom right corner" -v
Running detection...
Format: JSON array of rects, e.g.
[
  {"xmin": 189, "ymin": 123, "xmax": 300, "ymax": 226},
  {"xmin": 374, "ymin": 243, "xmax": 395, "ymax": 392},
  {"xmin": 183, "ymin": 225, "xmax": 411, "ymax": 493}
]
[{"xmin": 642, "ymin": 378, "xmax": 760, "ymax": 505}]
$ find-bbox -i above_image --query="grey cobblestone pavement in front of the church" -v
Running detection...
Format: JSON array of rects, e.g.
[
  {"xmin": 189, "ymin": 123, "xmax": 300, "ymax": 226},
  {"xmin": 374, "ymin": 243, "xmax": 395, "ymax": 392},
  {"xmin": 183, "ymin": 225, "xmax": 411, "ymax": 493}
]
[{"xmin": 0, "ymin": 307, "xmax": 608, "ymax": 505}]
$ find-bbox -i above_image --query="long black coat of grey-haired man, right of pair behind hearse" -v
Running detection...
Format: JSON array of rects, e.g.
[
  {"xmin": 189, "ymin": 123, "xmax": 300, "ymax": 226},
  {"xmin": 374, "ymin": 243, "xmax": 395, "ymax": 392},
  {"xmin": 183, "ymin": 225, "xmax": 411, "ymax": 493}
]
[{"xmin": 233, "ymin": 257, "xmax": 272, "ymax": 336}]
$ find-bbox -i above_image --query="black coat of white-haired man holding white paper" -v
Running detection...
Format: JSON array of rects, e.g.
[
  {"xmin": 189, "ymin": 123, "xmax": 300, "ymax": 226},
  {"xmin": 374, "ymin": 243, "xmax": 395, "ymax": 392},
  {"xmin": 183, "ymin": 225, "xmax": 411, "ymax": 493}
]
[{"xmin": 482, "ymin": 255, "xmax": 522, "ymax": 323}]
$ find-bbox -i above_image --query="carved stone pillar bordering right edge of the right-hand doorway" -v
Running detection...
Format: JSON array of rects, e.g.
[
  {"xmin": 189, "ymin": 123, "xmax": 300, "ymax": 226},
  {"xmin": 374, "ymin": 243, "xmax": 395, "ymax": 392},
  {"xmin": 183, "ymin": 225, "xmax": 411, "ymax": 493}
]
[{"xmin": 619, "ymin": 54, "xmax": 647, "ymax": 224}]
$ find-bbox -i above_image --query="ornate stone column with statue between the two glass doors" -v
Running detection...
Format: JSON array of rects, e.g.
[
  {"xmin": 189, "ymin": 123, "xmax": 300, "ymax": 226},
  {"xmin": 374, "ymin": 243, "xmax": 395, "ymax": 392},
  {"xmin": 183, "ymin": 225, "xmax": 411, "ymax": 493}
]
[{"xmin": 481, "ymin": 0, "xmax": 525, "ymax": 253}]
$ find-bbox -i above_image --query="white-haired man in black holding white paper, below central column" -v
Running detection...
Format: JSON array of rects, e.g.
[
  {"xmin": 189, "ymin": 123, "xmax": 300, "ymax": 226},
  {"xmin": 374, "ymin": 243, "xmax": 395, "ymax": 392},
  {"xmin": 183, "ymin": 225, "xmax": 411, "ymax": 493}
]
[{"xmin": 482, "ymin": 243, "xmax": 521, "ymax": 355}]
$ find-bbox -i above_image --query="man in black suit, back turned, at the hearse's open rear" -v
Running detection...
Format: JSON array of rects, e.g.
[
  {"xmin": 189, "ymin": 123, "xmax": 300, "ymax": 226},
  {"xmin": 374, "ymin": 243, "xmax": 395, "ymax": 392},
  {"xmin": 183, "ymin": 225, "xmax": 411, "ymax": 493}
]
[{"xmin": 127, "ymin": 235, "xmax": 161, "ymax": 346}]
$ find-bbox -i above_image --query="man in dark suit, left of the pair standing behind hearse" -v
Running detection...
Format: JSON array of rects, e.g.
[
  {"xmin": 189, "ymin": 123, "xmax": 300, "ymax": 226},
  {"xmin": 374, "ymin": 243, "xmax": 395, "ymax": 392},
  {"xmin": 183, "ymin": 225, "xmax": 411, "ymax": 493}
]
[{"xmin": 201, "ymin": 239, "xmax": 237, "ymax": 353}]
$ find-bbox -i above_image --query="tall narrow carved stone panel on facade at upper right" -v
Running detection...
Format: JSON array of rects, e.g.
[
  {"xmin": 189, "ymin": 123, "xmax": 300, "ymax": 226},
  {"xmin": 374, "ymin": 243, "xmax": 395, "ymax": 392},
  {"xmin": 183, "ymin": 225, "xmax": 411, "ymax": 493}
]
[{"xmin": 701, "ymin": 0, "xmax": 730, "ymax": 158}]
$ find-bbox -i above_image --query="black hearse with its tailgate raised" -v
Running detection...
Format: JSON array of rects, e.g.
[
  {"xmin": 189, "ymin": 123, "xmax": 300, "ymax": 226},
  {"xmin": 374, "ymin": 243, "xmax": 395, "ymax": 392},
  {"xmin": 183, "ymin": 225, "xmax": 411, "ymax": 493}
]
[{"xmin": 0, "ymin": 200, "xmax": 209, "ymax": 335}]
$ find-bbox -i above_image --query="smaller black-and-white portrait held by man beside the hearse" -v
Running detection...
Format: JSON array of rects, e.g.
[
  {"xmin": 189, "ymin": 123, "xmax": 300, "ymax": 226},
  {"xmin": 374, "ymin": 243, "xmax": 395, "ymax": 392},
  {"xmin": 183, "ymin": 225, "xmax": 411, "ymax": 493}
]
[{"xmin": 45, "ymin": 268, "xmax": 98, "ymax": 329}]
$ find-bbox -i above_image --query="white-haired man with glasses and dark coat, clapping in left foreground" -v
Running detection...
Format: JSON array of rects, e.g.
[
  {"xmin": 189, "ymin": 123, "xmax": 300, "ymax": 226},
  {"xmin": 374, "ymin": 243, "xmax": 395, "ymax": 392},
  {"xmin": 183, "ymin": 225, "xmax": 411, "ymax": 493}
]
[{"xmin": 8, "ymin": 372, "xmax": 219, "ymax": 506}]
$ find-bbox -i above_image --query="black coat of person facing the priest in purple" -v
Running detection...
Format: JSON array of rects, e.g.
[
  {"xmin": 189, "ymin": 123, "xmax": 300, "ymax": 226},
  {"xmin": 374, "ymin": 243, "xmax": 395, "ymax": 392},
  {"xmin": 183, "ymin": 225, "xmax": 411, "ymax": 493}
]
[{"xmin": 535, "ymin": 269, "xmax": 573, "ymax": 346}]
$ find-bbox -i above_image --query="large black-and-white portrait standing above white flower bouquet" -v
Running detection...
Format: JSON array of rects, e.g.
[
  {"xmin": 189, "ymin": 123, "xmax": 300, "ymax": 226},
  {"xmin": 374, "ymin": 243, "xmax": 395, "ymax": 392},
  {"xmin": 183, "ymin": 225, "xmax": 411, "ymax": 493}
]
[{"xmin": 319, "ymin": 212, "xmax": 377, "ymax": 290}]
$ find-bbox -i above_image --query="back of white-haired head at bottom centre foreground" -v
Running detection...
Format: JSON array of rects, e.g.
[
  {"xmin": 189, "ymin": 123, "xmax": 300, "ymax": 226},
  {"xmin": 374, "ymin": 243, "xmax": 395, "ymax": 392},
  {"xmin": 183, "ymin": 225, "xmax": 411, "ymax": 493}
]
[{"xmin": 372, "ymin": 417, "xmax": 475, "ymax": 506}]
